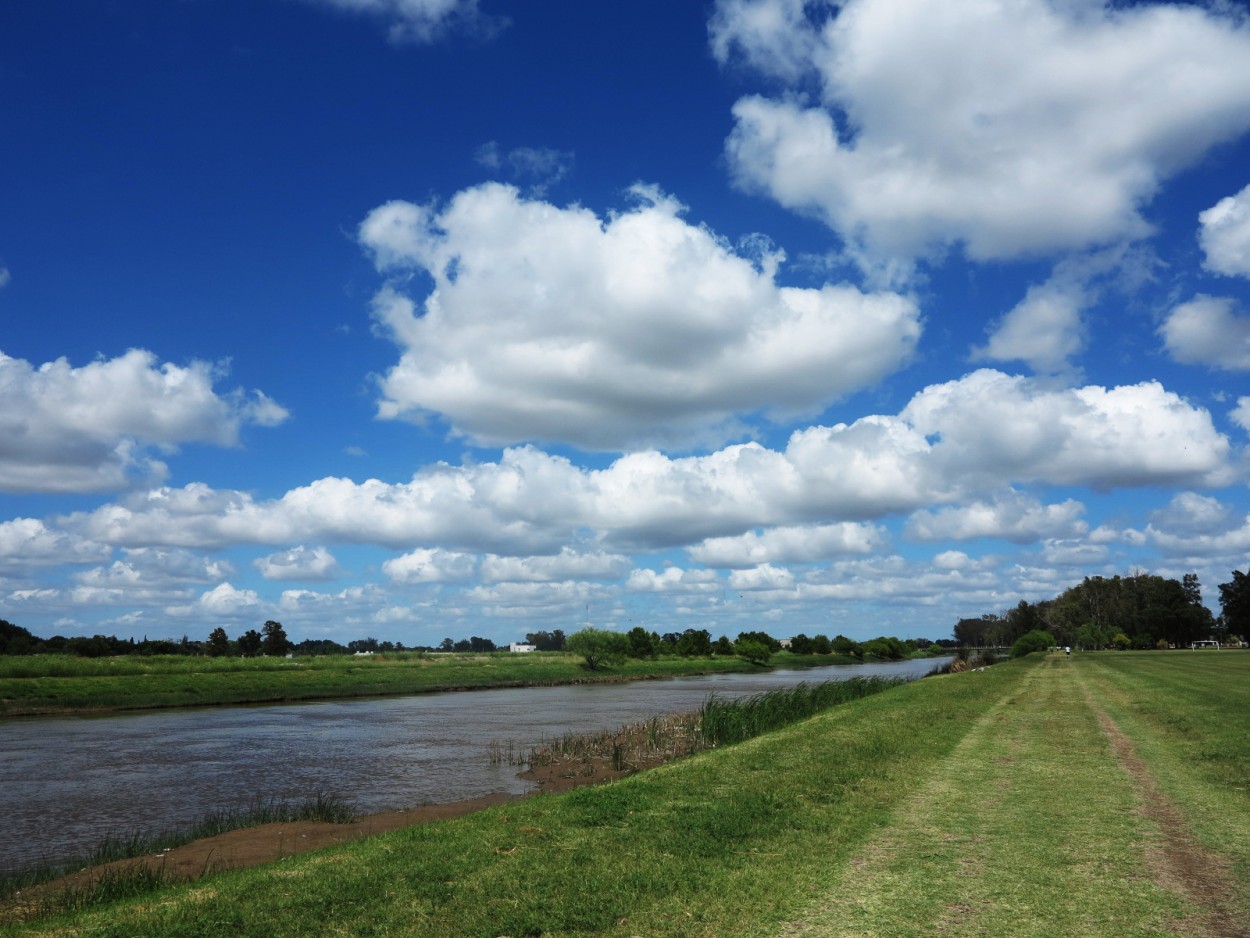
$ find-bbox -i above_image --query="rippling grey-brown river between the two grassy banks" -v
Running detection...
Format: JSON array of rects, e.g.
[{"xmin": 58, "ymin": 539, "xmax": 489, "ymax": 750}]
[{"xmin": 0, "ymin": 659, "xmax": 945, "ymax": 869}]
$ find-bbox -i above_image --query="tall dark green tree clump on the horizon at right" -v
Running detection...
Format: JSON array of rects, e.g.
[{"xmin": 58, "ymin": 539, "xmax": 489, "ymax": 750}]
[{"xmin": 955, "ymin": 572, "xmax": 1250, "ymax": 648}]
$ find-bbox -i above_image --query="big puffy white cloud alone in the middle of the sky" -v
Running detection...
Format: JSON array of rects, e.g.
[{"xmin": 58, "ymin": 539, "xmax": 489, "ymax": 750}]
[{"xmin": 360, "ymin": 184, "xmax": 920, "ymax": 450}]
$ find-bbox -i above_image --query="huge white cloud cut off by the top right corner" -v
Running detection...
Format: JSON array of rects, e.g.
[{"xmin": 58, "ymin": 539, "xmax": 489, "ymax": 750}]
[{"xmin": 713, "ymin": 0, "xmax": 1250, "ymax": 265}]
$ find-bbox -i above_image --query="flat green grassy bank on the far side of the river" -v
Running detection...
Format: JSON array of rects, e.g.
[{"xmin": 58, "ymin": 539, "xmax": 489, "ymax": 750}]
[{"xmin": 0, "ymin": 652, "xmax": 880, "ymax": 718}]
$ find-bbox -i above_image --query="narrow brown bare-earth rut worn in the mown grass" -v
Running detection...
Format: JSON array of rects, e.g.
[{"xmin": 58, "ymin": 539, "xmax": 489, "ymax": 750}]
[{"xmin": 1098, "ymin": 710, "xmax": 1250, "ymax": 938}]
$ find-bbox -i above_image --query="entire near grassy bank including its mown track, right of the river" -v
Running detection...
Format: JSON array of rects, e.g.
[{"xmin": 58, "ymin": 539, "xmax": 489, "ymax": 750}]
[{"xmin": 7, "ymin": 652, "xmax": 1250, "ymax": 938}]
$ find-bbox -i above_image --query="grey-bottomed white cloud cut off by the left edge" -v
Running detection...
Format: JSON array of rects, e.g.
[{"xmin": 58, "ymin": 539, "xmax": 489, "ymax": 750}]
[{"xmin": 0, "ymin": 349, "xmax": 288, "ymax": 492}]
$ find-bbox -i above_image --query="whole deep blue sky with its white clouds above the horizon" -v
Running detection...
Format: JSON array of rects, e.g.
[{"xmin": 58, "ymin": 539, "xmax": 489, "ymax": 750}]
[{"xmin": 0, "ymin": 0, "xmax": 1250, "ymax": 644}]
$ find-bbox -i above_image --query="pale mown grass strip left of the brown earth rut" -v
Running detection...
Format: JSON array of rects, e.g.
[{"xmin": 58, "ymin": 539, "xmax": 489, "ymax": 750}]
[{"xmin": 779, "ymin": 658, "xmax": 1200, "ymax": 938}]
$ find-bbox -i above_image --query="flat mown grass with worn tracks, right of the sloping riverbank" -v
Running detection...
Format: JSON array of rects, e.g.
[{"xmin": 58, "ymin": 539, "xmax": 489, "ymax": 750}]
[{"xmin": 785, "ymin": 652, "xmax": 1250, "ymax": 938}]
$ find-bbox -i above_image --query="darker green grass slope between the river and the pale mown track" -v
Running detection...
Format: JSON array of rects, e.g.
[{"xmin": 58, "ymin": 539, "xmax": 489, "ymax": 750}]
[{"xmin": 4, "ymin": 664, "xmax": 1015, "ymax": 938}]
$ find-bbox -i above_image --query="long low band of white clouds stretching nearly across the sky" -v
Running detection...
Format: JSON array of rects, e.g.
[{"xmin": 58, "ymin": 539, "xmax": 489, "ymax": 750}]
[{"xmin": 63, "ymin": 370, "xmax": 1234, "ymax": 555}]
